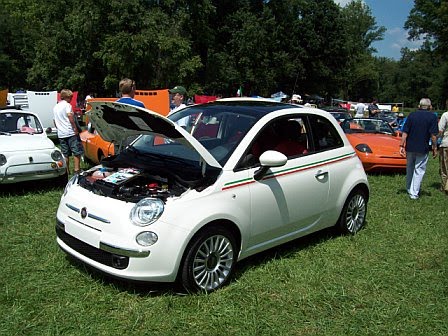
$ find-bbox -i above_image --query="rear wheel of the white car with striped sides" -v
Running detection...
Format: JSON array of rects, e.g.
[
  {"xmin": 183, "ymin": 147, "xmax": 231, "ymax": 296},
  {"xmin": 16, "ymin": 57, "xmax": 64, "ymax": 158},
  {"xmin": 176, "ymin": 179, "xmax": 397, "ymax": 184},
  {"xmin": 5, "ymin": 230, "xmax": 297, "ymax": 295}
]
[{"xmin": 337, "ymin": 189, "xmax": 367, "ymax": 234}]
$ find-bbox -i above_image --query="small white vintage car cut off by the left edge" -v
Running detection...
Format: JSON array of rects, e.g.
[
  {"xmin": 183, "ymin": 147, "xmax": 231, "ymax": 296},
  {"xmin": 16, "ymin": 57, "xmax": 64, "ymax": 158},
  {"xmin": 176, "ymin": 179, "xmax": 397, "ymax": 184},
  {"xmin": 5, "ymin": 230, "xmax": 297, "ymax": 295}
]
[{"xmin": 0, "ymin": 108, "xmax": 68, "ymax": 186}]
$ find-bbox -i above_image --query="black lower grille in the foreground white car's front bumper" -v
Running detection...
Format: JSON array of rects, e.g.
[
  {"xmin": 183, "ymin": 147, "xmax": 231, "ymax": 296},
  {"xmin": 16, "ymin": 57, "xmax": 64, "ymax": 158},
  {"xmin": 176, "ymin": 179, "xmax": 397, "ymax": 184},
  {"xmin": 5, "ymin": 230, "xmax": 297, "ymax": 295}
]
[{"xmin": 56, "ymin": 222, "xmax": 129, "ymax": 269}]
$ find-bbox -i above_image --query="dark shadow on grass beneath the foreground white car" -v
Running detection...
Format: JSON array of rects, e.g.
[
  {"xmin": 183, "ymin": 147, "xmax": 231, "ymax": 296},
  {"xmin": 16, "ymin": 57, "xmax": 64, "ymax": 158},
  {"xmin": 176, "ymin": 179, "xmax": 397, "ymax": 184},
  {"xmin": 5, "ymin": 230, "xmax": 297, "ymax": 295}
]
[{"xmin": 62, "ymin": 228, "xmax": 338, "ymax": 297}]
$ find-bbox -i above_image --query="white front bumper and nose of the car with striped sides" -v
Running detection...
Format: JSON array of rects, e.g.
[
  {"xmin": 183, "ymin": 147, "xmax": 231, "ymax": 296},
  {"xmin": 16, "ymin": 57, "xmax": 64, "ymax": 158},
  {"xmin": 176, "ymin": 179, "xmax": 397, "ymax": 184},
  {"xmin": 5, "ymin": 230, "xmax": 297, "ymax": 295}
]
[{"xmin": 56, "ymin": 186, "xmax": 189, "ymax": 282}]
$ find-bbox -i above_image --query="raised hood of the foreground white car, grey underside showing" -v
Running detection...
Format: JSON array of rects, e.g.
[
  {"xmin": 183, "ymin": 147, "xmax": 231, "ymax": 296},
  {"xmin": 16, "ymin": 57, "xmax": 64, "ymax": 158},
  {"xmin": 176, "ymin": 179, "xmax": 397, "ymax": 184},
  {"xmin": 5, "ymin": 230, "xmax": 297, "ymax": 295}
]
[{"xmin": 87, "ymin": 101, "xmax": 222, "ymax": 168}]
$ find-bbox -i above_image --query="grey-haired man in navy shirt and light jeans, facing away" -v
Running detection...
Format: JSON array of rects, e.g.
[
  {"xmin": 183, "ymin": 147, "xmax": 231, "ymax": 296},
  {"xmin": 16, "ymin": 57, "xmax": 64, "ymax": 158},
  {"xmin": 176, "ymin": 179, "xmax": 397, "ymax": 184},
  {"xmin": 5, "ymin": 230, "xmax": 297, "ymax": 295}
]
[{"xmin": 400, "ymin": 98, "xmax": 438, "ymax": 199}]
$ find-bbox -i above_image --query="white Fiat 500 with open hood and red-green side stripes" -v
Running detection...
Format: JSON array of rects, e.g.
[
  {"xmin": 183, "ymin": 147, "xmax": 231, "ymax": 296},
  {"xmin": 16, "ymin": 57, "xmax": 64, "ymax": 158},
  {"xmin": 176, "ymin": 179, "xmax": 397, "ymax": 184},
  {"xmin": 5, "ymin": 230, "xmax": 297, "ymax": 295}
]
[{"xmin": 56, "ymin": 98, "xmax": 369, "ymax": 292}]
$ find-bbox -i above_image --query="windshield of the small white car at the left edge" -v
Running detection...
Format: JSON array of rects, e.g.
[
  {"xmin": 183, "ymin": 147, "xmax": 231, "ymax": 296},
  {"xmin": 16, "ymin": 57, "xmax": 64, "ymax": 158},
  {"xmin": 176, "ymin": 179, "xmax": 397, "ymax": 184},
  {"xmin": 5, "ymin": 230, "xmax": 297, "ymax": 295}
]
[{"xmin": 0, "ymin": 112, "xmax": 43, "ymax": 134}]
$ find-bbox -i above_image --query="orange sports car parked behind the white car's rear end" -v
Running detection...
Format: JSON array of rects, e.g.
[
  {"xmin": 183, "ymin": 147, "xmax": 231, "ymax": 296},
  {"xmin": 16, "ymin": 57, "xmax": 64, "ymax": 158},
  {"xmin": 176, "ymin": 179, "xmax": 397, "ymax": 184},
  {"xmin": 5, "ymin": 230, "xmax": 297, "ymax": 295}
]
[{"xmin": 341, "ymin": 118, "xmax": 406, "ymax": 171}]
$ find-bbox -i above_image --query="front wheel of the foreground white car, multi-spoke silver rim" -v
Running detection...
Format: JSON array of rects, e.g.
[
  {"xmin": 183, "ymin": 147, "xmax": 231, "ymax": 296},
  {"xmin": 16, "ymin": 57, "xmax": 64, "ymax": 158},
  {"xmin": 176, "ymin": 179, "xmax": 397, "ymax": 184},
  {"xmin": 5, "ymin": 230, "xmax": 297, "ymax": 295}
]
[{"xmin": 181, "ymin": 227, "xmax": 238, "ymax": 293}]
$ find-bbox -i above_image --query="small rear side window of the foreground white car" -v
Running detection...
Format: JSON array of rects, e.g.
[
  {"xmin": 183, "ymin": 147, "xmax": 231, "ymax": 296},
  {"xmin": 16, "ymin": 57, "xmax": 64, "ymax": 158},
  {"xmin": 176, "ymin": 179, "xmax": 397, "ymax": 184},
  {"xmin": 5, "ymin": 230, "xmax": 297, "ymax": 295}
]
[{"xmin": 309, "ymin": 116, "xmax": 343, "ymax": 152}]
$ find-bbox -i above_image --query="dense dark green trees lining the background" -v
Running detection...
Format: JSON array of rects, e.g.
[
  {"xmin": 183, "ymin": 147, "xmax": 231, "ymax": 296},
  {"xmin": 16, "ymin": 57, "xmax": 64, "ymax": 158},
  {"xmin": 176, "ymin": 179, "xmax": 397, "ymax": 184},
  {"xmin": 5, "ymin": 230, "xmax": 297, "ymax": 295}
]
[{"xmin": 0, "ymin": 0, "xmax": 447, "ymax": 104}]
